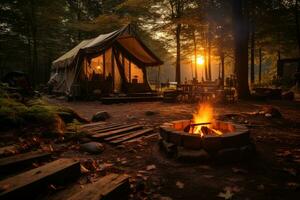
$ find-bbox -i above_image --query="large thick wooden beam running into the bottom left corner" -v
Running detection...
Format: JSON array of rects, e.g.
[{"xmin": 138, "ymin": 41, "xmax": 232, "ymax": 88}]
[{"xmin": 0, "ymin": 158, "xmax": 80, "ymax": 199}]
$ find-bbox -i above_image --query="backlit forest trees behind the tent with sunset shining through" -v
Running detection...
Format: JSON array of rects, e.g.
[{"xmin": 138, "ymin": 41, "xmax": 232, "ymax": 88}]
[{"xmin": 0, "ymin": 0, "xmax": 300, "ymax": 97}]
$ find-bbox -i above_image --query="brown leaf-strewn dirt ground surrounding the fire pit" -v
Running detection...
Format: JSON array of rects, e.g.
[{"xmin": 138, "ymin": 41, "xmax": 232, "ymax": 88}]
[{"xmin": 48, "ymin": 99, "xmax": 300, "ymax": 200}]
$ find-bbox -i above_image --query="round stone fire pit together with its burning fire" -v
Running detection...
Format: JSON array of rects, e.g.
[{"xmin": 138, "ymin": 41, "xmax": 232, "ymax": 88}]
[{"xmin": 160, "ymin": 104, "xmax": 255, "ymax": 161}]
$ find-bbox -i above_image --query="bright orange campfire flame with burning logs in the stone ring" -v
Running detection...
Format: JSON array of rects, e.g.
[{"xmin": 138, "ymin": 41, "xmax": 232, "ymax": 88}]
[{"xmin": 189, "ymin": 103, "xmax": 223, "ymax": 137}]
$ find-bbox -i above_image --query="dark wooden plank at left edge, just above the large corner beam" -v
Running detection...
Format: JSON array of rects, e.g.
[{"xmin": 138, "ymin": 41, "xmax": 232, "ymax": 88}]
[{"xmin": 0, "ymin": 151, "xmax": 51, "ymax": 174}]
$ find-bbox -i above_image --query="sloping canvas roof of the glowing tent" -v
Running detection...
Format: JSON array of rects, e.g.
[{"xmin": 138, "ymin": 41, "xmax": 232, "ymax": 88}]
[{"xmin": 52, "ymin": 25, "xmax": 163, "ymax": 69}]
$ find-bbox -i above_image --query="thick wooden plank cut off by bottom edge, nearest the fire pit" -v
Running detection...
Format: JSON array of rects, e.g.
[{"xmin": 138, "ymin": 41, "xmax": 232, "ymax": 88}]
[{"xmin": 67, "ymin": 174, "xmax": 130, "ymax": 200}]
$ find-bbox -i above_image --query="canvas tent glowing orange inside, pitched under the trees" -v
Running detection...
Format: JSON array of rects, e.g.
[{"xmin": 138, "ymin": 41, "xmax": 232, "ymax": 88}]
[{"xmin": 49, "ymin": 25, "xmax": 163, "ymax": 95}]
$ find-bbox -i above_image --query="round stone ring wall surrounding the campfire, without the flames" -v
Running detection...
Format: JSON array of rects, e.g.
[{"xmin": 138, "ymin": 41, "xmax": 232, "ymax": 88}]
[{"xmin": 160, "ymin": 120, "xmax": 254, "ymax": 160}]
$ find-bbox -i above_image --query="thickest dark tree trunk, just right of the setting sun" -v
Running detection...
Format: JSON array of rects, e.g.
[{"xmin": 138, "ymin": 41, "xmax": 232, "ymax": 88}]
[{"xmin": 232, "ymin": 0, "xmax": 250, "ymax": 99}]
